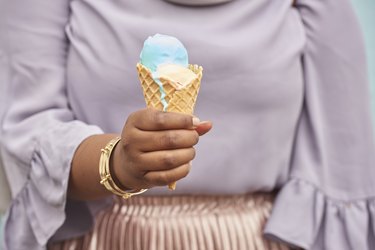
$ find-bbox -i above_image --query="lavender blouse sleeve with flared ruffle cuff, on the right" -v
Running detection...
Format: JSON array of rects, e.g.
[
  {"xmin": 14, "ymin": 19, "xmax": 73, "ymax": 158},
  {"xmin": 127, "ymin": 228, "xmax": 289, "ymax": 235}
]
[{"xmin": 265, "ymin": 0, "xmax": 375, "ymax": 250}]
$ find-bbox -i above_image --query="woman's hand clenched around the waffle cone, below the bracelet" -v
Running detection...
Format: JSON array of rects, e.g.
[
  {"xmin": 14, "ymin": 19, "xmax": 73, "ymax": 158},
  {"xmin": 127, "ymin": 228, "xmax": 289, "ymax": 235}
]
[{"xmin": 111, "ymin": 109, "xmax": 212, "ymax": 189}]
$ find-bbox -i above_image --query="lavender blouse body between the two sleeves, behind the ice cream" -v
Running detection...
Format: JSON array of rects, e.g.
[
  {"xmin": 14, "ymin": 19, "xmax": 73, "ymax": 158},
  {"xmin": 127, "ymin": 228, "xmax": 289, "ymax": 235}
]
[{"xmin": 67, "ymin": 0, "xmax": 304, "ymax": 194}]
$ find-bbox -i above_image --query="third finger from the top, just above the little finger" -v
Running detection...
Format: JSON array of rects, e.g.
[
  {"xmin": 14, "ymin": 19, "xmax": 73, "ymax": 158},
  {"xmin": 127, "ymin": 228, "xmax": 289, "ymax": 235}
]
[{"xmin": 139, "ymin": 148, "xmax": 195, "ymax": 172}]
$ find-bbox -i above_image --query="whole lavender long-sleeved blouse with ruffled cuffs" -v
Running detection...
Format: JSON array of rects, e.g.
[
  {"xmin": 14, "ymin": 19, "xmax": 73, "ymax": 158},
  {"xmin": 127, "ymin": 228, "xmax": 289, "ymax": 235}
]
[{"xmin": 0, "ymin": 0, "xmax": 375, "ymax": 250}]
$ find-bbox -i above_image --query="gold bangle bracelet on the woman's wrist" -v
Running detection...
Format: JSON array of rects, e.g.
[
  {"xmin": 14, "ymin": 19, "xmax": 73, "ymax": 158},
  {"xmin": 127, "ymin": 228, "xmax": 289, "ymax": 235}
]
[{"xmin": 99, "ymin": 137, "xmax": 147, "ymax": 199}]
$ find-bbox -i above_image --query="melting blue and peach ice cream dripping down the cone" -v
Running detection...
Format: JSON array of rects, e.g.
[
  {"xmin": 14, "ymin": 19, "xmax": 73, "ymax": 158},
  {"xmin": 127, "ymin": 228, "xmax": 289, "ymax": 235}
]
[{"xmin": 140, "ymin": 34, "xmax": 196, "ymax": 111}]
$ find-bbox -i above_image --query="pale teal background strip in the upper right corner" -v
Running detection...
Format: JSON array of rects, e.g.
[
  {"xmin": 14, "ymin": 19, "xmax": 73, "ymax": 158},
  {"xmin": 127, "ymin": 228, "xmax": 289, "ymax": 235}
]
[{"xmin": 353, "ymin": 0, "xmax": 375, "ymax": 125}]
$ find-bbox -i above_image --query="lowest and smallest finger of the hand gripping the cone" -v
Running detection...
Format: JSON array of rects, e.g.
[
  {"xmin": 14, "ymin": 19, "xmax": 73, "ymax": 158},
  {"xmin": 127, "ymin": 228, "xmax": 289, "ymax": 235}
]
[{"xmin": 144, "ymin": 163, "xmax": 191, "ymax": 186}]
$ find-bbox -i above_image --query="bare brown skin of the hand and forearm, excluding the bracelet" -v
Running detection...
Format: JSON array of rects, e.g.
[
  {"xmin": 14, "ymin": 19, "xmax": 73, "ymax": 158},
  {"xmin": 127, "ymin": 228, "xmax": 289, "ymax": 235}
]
[{"xmin": 68, "ymin": 109, "xmax": 212, "ymax": 200}]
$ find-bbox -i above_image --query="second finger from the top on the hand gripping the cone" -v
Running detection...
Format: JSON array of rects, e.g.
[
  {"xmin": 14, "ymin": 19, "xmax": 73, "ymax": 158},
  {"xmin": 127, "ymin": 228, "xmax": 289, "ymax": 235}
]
[{"xmin": 127, "ymin": 130, "xmax": 199, "ymax": 152}]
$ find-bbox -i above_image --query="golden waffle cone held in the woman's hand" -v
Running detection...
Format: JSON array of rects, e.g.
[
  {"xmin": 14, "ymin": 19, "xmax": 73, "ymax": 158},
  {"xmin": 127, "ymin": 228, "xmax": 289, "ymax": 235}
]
[{"xmin": 137, "ymin": 63, "xmax": 203, "ymax": 190}]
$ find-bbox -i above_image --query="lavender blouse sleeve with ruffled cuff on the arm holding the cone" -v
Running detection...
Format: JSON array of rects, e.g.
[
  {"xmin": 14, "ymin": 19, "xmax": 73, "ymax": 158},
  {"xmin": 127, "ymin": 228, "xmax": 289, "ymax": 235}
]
[{"xmin": 0, "ymin": 0, "xmax": 102, "ymax": 249}]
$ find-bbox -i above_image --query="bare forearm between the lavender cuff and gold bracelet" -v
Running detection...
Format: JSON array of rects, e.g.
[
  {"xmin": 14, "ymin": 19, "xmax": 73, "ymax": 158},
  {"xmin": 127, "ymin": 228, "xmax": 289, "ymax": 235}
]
[{"xmin": 68, "ymin": 134, "xmax": 118, "ymax": 200}]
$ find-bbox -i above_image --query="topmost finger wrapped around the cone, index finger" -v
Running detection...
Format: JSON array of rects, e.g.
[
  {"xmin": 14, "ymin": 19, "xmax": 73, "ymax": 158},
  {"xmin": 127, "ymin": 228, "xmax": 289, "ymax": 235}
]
[{"xmin": 128, "ymin": 108, "xmax": 199, "ymax": 131}]
